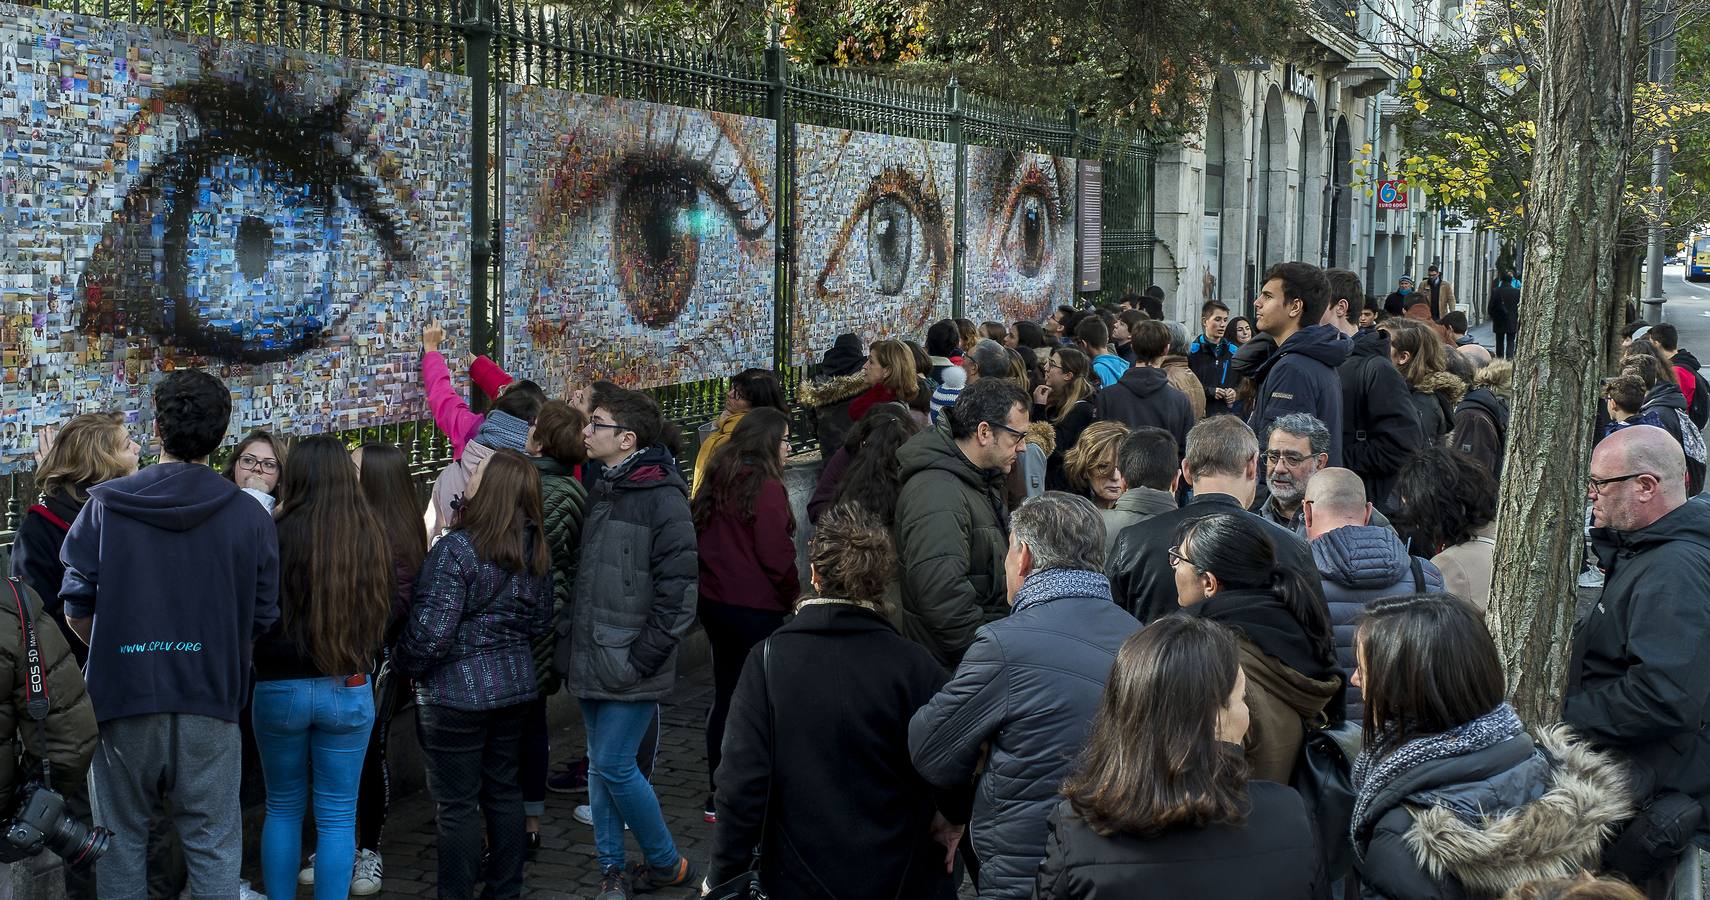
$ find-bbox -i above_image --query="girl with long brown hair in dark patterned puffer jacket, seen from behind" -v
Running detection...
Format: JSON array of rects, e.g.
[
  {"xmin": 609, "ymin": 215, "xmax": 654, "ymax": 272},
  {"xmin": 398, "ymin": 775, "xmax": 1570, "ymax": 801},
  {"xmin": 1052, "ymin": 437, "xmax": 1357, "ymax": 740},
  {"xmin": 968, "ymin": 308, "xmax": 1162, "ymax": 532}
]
[{"xmin": 397, "ymin": 451, "xmax": 552, "ymax": 900}]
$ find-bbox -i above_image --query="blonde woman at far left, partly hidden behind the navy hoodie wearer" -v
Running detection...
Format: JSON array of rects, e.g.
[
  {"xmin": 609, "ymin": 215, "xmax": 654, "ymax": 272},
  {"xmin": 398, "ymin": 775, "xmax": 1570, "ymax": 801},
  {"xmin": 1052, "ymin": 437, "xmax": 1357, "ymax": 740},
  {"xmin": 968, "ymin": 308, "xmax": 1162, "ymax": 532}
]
[{"xmin": 12, "ymin": 412, "xmax": 142, "ymax": 666}]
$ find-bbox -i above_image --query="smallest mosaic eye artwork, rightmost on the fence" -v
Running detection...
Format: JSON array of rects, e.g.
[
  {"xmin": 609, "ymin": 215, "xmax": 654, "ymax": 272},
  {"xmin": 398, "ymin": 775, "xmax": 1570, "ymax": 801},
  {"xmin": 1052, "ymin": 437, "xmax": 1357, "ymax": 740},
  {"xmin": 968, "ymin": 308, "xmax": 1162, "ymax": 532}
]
[{"xmin": 963, "ymin": 147, "xmax": 1076, "ymax": 325}]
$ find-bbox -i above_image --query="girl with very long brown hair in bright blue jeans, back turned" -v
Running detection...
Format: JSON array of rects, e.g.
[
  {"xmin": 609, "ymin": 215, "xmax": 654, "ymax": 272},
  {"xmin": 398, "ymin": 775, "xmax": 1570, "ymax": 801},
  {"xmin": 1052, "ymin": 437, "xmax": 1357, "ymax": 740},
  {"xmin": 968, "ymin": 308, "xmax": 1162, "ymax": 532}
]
[{"xmin": 251, "ymin": 435, "xmax": 393, "ymax": 900}]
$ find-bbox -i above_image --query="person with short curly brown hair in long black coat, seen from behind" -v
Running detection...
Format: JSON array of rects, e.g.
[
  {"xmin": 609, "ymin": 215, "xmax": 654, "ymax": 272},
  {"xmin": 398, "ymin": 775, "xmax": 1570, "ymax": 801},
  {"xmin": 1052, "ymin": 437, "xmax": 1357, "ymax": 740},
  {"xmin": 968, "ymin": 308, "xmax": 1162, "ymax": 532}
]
[{"xmin": 706, "ymin": 505, "xmax": 971, "ymax": 900}]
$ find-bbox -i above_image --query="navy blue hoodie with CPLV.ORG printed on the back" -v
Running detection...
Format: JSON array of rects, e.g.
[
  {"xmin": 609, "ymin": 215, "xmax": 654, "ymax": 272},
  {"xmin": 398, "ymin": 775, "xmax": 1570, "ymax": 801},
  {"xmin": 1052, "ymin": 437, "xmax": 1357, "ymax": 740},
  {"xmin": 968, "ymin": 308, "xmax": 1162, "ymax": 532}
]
[{"xmin": 60, "ymin": 462, "xmax": 279, "ymax": 722}]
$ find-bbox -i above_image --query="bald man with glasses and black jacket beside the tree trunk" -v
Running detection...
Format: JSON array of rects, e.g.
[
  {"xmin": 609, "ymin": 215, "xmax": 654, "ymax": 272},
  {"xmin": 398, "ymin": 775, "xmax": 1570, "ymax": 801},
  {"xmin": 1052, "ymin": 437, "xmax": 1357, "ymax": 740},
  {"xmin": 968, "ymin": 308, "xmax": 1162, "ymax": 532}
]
[{"xmin": 1561, "ymin": 424, "xmax": 1710, "ymax": 897}]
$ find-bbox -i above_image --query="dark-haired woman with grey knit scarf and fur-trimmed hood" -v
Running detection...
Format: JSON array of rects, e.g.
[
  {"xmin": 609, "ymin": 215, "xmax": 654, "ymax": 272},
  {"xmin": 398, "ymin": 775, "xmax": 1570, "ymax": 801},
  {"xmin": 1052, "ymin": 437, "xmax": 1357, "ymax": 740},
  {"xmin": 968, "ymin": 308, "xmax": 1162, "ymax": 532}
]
[{"xmin": 1351, "ymin": 594, "xmax": 1631, "ymax": 900}]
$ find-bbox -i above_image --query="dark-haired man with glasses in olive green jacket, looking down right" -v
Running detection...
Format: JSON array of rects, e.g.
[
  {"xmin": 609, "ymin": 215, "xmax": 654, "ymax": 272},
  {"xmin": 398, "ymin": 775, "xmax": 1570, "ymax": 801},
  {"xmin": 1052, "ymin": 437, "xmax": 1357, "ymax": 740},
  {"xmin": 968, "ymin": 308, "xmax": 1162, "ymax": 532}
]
[{"xmin": 894, "ymin": 378, "xmax": 1028, "ymax": 669}]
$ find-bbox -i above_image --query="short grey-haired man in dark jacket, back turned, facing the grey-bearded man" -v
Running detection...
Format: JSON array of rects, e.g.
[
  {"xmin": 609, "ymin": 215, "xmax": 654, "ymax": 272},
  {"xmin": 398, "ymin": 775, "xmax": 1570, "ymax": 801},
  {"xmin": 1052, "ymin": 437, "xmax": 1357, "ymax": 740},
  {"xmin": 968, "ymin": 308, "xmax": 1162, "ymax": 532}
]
[{"xmin": 1105, "ymin": 416, "xmax": 1318, "ymax": 623}]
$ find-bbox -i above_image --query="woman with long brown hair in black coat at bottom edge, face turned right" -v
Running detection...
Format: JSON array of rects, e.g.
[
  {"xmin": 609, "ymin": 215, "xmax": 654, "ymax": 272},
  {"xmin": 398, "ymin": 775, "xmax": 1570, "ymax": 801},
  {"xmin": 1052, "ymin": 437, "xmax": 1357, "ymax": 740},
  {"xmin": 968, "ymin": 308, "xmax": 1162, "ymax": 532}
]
[{"xmin": 1033, "ymin": 616, "xmax": 1327, "ymax": 900}]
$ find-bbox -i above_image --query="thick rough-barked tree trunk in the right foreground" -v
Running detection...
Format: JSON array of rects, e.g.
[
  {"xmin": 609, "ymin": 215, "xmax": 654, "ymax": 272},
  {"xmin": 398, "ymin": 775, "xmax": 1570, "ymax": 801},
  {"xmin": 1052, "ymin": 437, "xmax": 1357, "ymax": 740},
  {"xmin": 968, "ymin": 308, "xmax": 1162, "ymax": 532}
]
[{"xmin": 1489, "ymin": 0, "xmax": 1640, "ymax": 727}]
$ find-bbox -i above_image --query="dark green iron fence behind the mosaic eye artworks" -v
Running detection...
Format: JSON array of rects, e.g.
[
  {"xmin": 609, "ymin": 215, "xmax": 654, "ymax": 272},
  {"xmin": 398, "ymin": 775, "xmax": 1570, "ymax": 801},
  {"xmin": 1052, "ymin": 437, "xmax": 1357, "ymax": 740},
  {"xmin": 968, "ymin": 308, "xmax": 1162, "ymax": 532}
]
[{"xmin": 0, "ymin": 0, "xmax": 1154, "ymax": 542}]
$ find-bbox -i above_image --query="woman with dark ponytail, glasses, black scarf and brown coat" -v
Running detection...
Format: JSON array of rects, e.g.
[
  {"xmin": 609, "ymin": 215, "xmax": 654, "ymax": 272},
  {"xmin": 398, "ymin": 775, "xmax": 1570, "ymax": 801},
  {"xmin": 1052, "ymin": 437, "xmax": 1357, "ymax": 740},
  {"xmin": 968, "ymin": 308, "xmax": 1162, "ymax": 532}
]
[{"xmin": 1170, "ymin": 513, "xmax": 1347, "ymax": 784}]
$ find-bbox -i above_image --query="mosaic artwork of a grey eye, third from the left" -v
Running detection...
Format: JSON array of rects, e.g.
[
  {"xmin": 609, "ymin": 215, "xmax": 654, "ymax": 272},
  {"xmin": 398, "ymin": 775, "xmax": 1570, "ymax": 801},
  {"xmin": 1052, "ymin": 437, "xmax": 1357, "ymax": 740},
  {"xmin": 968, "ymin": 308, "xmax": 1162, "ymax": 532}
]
[{"xmin": 792, "ymin": 125, "xmax": 956, "ymax": 361}]
